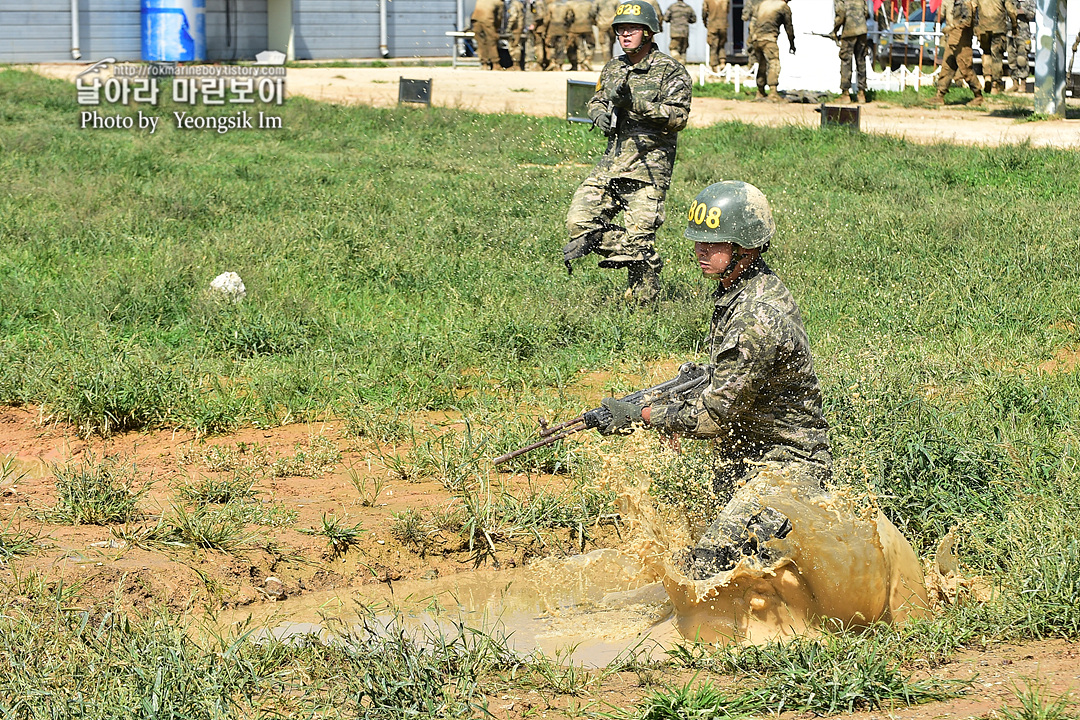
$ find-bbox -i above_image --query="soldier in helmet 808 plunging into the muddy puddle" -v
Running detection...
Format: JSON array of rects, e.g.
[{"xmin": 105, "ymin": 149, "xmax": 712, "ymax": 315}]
[{"xmin": 602, "ymin": 180, "xmax": 833, "ymax": 580}]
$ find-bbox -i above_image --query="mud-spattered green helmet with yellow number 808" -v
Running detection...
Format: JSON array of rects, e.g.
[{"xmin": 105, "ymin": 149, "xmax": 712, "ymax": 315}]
[{"xmin": 684, "ymin": 180, "xmax": 777, "ymax": 252}]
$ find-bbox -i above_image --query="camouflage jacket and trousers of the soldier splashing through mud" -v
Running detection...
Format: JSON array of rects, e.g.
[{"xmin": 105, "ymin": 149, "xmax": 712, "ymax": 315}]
[{"xmin": 649, "ymin": 258, "xmax": 833, "ymax": 579}]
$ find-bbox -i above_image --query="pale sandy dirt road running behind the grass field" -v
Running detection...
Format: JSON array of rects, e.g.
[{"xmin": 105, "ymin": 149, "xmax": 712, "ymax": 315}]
[{"xmin": 31, "ymin": 64, "xmax": 1080, "ymax": 148}]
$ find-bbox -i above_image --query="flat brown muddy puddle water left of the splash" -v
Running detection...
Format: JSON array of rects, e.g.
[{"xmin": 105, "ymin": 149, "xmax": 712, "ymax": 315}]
[{"xmin": 217, "ymin": 549, "xmax": 678, "ymax": 667}]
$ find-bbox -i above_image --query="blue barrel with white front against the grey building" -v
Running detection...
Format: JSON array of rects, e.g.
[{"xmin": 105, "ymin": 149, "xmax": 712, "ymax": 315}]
[{"xmin": 141, "ymin": 0, "xmax": 206, "ymax": 63}]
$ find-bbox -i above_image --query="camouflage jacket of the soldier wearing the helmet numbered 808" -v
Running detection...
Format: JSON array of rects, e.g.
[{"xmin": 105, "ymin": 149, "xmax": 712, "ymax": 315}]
[{"xmin": 650, "ymin": 260, "xmax": 832, "ymax": 465}]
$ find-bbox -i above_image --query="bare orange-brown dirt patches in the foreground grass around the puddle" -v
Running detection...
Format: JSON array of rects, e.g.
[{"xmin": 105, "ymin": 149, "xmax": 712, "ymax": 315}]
[{"xmin": 0, "ymin": 407, "xmax": 1080, "ymax": 720}]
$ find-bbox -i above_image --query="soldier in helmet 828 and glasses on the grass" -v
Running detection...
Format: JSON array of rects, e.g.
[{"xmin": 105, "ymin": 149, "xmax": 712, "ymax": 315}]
[{"xmin": 563, "ymin": 0, "xmax": 691, "ymax": 303}]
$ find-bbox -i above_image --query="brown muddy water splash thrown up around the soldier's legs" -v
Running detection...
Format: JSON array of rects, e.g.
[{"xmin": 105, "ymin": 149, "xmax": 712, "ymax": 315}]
[{"xmin": 609, "ymin": 442, "xmax": 929, "ymax": 643}]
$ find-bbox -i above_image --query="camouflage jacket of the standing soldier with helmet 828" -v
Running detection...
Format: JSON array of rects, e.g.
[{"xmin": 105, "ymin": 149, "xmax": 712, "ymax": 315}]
[{"xmin": 589, "ymin": 44, "xmax": 692, "ymax": 190}]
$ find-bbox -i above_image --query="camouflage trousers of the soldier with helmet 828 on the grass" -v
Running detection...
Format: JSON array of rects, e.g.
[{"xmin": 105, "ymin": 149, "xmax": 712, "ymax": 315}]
[{"xmin": 564, "ymin": 176, "xmax": 667, "ymax": 271}]
